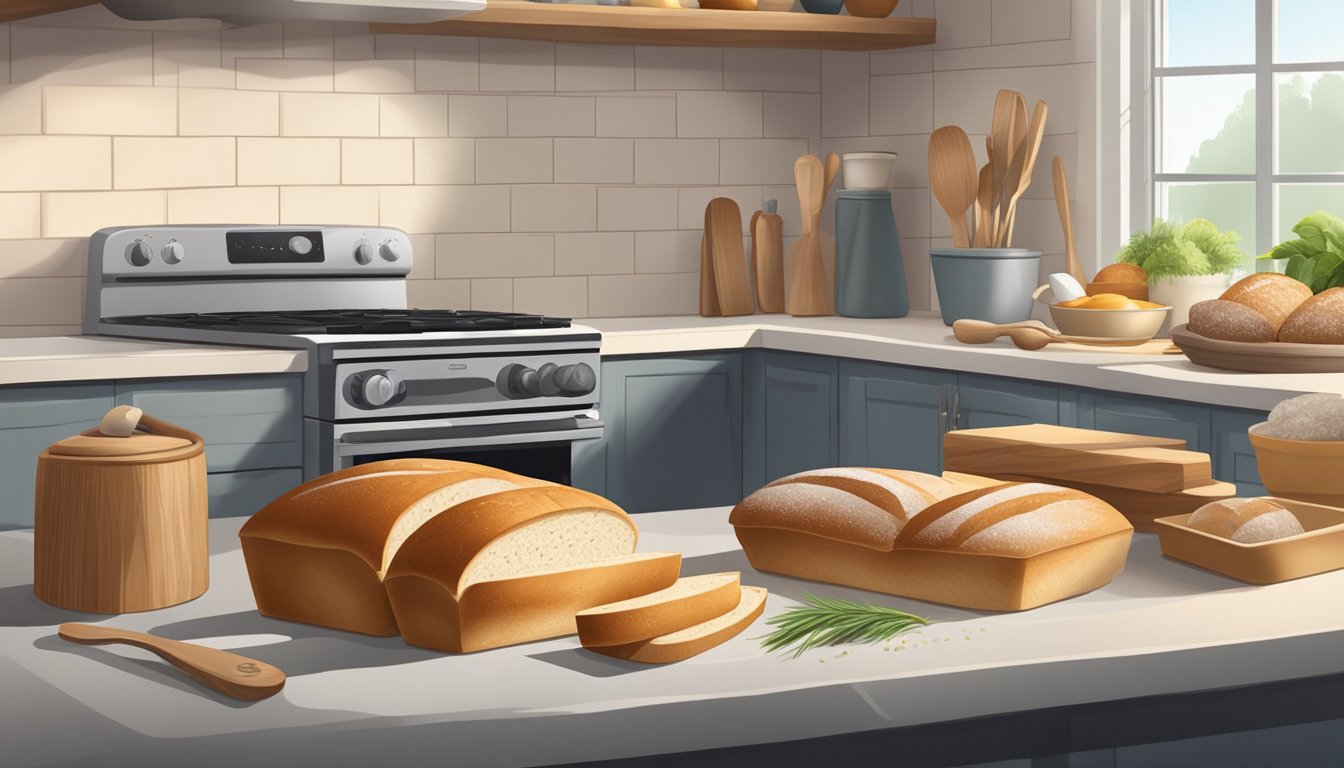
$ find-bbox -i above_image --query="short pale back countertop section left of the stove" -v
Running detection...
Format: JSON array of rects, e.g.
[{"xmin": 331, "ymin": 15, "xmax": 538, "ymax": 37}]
[{"xmin": 0, "ymin": 336, "xmax": 308, "ymax": 385}]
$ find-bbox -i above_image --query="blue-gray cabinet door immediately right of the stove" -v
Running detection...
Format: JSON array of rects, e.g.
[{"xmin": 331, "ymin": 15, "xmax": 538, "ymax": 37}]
[{"xmin": 601, "ymin": 352, "xmax": 742, "ymax": 512}]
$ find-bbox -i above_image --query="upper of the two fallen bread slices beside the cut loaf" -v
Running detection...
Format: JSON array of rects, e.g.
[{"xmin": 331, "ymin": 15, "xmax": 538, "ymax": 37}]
[{"xmin": 574, "ymin": 570, "xmax": 742, "ymax": 647}]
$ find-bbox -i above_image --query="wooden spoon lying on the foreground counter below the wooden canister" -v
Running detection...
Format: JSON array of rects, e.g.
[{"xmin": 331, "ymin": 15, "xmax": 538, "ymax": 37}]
[{"xmin": 56, "ymin": 624, "xmax": 285, "ymax": 701}]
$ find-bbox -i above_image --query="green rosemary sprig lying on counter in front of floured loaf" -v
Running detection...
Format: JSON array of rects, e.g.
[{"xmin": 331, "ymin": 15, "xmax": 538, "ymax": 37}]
[{"xmin": 761, "ymin": 592, "xmax": 929, "ymax": 659}]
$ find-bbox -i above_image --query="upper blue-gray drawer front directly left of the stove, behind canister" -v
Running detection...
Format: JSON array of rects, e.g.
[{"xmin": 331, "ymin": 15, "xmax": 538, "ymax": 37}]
[{"xmin": 117, "ymin": 374, "xmax": 304, "ymax": 472}]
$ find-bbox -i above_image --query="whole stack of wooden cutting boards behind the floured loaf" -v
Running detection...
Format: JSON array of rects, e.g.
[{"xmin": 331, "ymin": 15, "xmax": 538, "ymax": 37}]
[{"xmin": 942, "ymin": 424, "xmax": 1236, "ymax": 531}]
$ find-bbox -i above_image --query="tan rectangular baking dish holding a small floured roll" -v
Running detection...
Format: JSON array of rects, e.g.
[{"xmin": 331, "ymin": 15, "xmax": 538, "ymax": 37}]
[{"xmin": 1154, "ymin": 496, "xmax": 1344, "ymax": 584}]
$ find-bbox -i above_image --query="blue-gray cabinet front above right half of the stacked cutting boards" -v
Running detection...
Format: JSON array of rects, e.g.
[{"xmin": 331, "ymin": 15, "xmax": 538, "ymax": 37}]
[{"xmin": 1078, "ymin": 390, "xmax": 1212, "ymax": 453}]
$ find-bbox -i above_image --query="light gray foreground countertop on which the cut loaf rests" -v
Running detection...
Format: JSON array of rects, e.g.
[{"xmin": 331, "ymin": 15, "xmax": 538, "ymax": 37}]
[{"xmin": 0, "ymin": 508, "xmax": 1344, "ymax": 768}]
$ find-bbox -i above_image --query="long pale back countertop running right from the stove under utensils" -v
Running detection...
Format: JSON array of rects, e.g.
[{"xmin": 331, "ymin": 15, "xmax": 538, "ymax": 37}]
[{"xmin": 582, "ymin": 312, "xmax": 1344, "ymax": 410}]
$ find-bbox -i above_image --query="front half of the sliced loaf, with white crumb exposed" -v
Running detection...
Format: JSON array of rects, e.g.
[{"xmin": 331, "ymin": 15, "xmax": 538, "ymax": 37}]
[{"xmin": 384, "ymin": 486, "xmax": 681, "ymax": 652}]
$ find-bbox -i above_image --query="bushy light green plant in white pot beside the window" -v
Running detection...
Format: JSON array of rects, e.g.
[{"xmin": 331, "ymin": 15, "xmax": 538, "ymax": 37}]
[{"xmin": 1116, "ymin": 219, "xmax": 1246, "ymax": 328}]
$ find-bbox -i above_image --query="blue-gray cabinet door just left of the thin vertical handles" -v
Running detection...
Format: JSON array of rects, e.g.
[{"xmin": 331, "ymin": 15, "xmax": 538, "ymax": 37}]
[{"xmin": 839, "ymin": 360, "xmax": 957, "ymax": 473}]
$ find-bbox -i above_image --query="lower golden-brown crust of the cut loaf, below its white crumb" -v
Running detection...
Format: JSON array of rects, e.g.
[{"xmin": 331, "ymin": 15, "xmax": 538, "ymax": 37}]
[{"xmin": 386, "ymin": 551, "xmax": 681, "ymax": 654}]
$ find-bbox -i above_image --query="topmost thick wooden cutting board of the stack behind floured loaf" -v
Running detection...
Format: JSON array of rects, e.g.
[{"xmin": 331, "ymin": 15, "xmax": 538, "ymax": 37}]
[{"xmin": 943, "ymin": 425, "xmax": 1214, "ymax": 494}]
